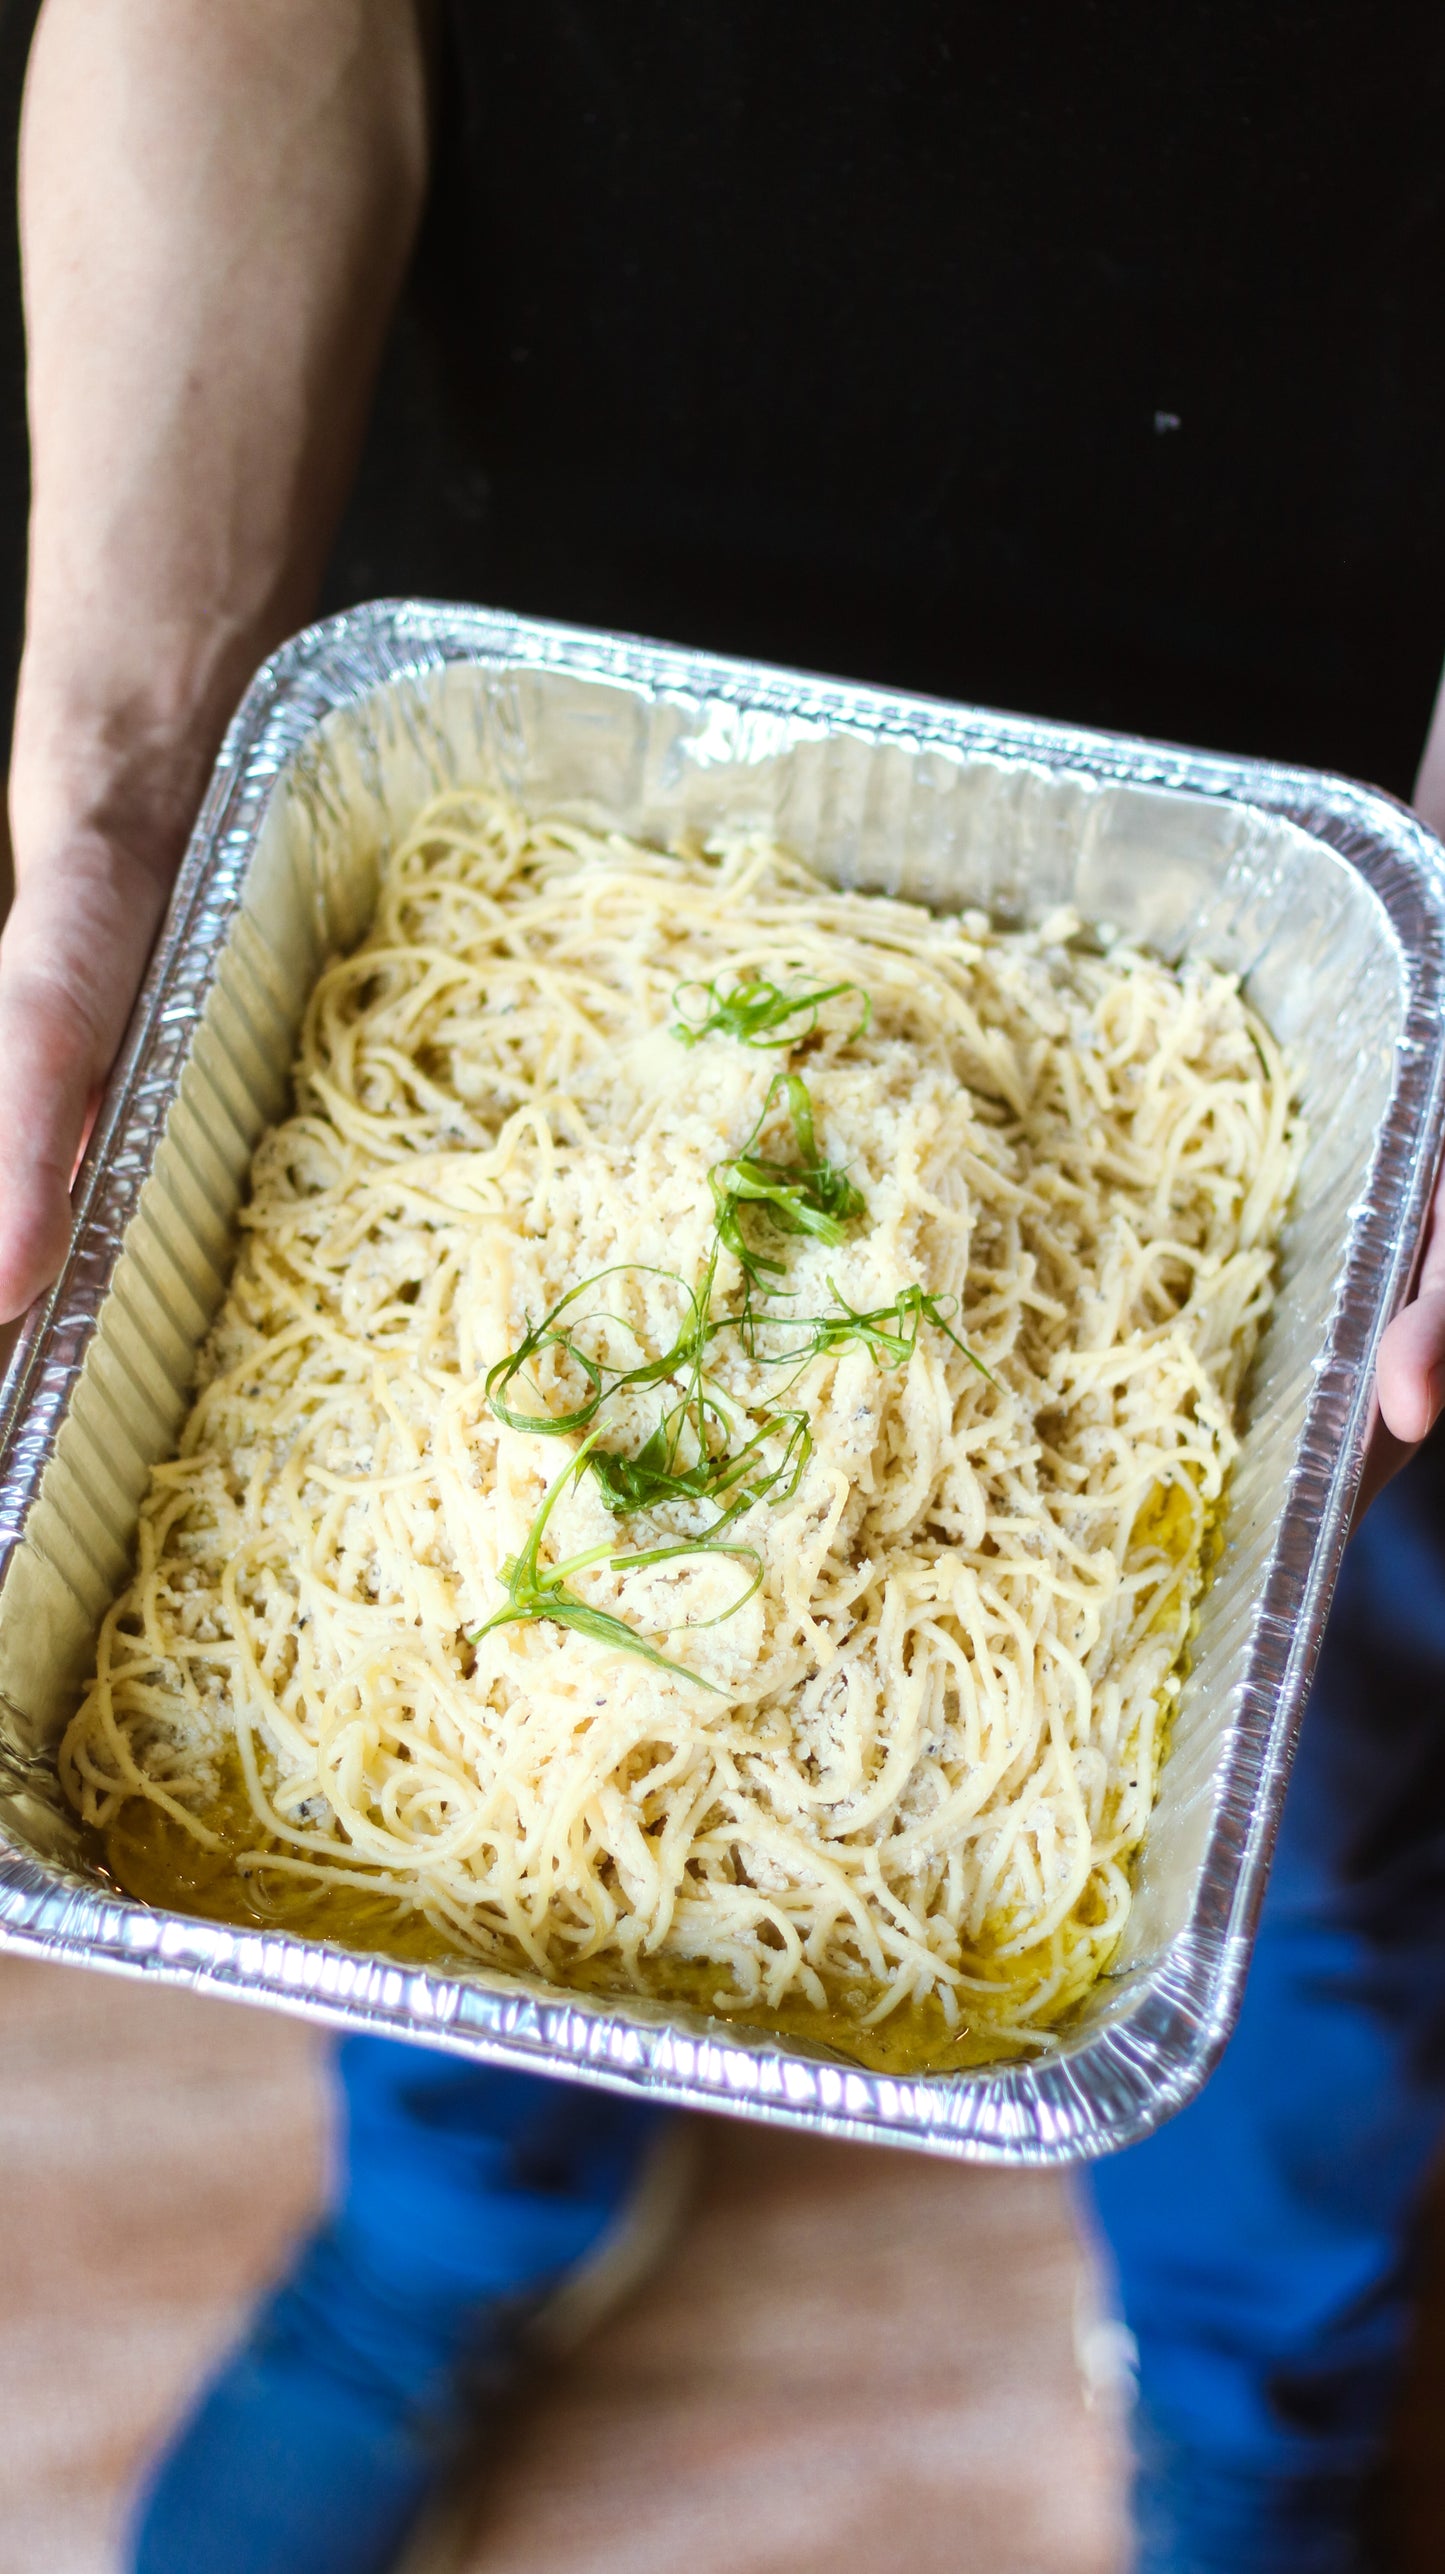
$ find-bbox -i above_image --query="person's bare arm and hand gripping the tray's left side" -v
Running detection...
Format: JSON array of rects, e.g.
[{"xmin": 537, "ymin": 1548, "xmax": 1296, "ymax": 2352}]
[{"xmin": 0, "ymin": 0, "xmax": 428, "ymax": 1318}]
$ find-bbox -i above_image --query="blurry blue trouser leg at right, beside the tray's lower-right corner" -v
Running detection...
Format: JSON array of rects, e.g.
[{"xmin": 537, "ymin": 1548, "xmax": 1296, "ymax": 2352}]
[{"xmin": 1087, "ymin": 1444, "xmax": 1445, "ymax": 2574}]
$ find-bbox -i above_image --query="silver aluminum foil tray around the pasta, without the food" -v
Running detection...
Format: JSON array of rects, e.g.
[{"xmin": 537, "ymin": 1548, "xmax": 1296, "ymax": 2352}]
[{"xmin": 0, "ymin": 602, "xmax": 1445, "ymax": 2162}]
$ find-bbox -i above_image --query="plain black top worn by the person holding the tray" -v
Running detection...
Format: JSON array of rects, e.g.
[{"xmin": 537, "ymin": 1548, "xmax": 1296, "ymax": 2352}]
[{"xmin": 327, "ymin": 0, "xmax": 1445, "ymax": 790}]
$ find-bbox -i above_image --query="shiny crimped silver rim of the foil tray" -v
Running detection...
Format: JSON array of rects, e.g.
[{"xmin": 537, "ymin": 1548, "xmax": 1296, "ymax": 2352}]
[{"xmin": 0, "ymin": 600, "xmax": 1445, "ymax": 2165}]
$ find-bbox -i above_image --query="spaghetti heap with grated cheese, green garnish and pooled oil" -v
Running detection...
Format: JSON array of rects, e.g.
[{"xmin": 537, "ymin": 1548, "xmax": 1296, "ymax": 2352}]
[{"xmin": 62, "ymin": 790, "xmax": 1298, "ymax": 2069}]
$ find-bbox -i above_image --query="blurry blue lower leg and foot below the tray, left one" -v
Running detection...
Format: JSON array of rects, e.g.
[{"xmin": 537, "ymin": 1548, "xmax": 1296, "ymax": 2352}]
[{"xmin": 129, "ymin": 2039, "xmax": 665, "ymax": 2574}]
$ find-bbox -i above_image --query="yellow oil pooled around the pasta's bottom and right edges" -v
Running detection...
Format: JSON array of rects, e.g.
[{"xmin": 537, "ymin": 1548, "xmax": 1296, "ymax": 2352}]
[{"xmin": 100, "ymin": 1485, "xmax": 1221, "ymax": 2077}]
